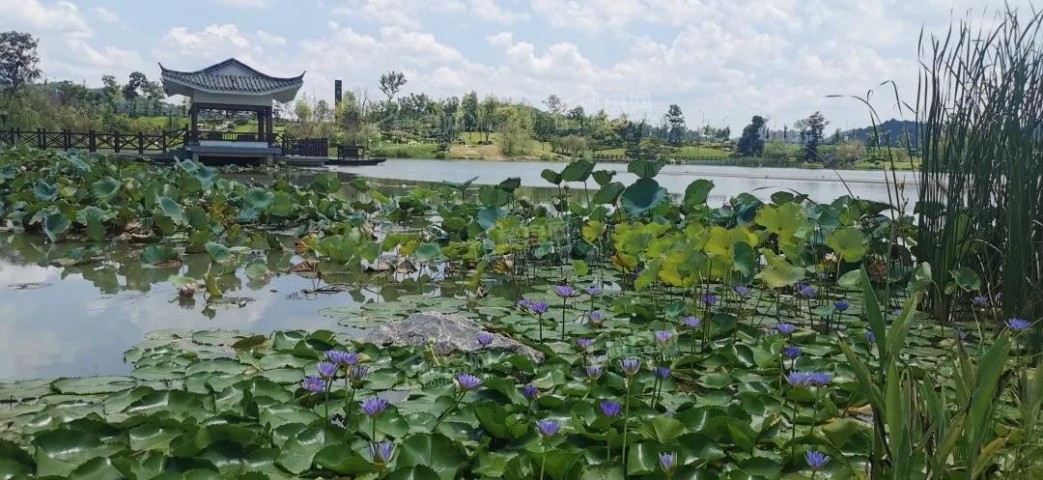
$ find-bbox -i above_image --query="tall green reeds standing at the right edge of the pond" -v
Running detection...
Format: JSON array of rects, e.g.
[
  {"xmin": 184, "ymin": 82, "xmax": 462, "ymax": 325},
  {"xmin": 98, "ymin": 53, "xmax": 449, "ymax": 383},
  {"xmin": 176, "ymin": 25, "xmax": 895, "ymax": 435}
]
[{"xmin": 916, "ymin": 8, "xmax": 1043, "ymax": 333}]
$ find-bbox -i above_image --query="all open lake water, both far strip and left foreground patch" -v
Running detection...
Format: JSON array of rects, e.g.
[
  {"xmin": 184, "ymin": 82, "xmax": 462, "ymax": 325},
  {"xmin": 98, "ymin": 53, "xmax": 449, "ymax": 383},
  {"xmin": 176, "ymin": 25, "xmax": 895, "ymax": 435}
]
[{"xmin": 0, "ymin": 160, "xmax": 916, "ymax": 382}]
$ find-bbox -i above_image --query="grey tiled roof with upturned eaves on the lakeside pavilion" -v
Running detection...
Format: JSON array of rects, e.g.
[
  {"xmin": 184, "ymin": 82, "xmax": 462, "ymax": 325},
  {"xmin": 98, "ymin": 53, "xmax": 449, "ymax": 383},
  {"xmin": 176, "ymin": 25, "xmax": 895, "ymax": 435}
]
[{"xmin": 160, "ymin": 58, "xmax": 305, "ymax": 95}]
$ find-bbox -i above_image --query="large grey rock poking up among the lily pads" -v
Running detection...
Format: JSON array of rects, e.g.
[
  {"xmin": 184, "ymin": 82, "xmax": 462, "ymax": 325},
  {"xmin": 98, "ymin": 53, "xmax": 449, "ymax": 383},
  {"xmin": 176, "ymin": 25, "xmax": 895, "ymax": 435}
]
[{"xmin": 363, "ymin": 312, "xmax": 543, "ymax": 362}]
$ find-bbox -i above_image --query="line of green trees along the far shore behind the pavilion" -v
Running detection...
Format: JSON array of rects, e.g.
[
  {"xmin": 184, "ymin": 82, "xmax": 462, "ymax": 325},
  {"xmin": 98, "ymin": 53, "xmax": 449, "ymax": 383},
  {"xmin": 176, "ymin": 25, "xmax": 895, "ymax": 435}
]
[{"xmin": 0, "ymin": 31, "xmax": 896, "ymax": 162}]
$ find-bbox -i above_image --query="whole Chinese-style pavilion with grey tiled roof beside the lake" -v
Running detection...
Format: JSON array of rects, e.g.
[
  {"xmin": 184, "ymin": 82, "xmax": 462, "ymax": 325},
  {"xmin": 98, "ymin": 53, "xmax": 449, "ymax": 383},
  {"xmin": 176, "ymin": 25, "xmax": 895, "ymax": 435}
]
[{"xmin": 160, "ymin": 58, "xmax": 305, "ymax": 164}]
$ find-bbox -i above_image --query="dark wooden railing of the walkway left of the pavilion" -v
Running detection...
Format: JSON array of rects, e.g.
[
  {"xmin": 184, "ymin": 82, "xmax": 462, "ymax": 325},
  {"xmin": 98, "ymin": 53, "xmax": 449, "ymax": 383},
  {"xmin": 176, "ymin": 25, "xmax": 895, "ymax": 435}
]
[{"xmin": 0, "ymin": 128, "xmax": 187, "ymax": 154}]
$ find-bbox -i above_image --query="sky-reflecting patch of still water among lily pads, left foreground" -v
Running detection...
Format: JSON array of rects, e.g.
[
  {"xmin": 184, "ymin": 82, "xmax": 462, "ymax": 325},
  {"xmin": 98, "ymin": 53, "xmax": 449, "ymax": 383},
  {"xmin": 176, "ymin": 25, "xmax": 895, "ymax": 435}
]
[{"xmin": 0, "ymin": 235, "xmax": 371, "ymax": 381}]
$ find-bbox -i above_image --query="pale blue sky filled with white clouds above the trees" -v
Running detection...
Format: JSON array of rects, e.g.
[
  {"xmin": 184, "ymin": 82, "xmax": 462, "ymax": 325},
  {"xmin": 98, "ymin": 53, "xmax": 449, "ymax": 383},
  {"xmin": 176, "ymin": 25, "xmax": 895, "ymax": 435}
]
[{"xmin": 0, "ymin": 0, "xmax": 1030, "ymax": 133}]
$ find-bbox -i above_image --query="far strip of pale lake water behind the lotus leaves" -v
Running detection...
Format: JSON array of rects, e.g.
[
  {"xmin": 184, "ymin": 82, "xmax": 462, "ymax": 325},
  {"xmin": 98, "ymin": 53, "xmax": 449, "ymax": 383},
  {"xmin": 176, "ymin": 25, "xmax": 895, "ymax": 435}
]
[{"xmin": 332, "ymin": 159, "xmax": 917, "ymax": 205}]
